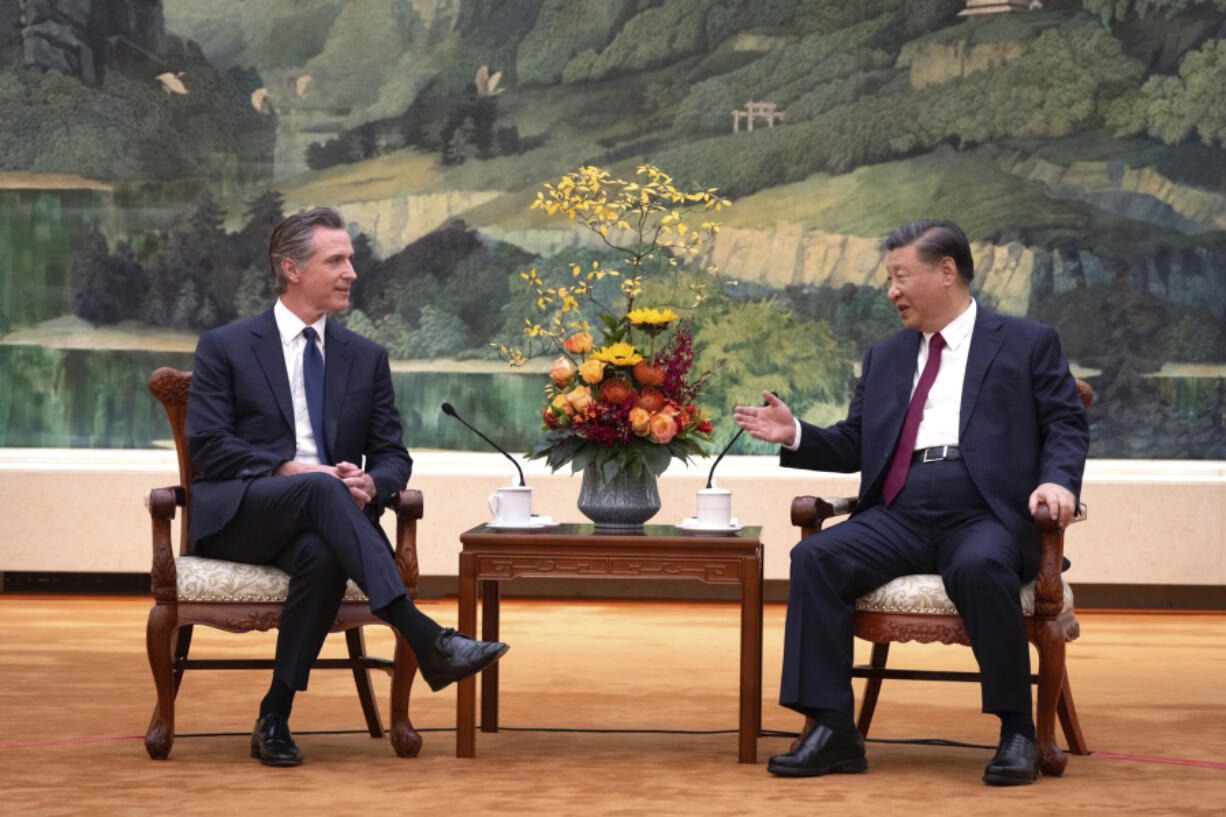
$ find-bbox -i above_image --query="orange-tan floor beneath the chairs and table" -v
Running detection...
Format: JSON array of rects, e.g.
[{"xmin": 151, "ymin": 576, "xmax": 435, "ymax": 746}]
[{"xmin": 0, "ymin": 594, "xmax": 1226, "ymax": 817}]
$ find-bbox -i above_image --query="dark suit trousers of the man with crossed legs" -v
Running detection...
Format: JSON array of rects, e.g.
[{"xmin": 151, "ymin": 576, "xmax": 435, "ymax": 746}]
[{"xmin": 196, "ymin": 472, "xmax": 406, "ymax": 689}]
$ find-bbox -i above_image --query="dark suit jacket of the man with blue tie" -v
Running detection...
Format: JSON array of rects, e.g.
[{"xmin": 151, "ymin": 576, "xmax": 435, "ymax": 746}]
[{"xmin": 185, "ymin": 309, "xmax": 413, "ymax": 546}]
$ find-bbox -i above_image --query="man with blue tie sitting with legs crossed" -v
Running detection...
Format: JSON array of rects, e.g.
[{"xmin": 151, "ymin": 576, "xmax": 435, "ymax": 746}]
[{"xmin": 186, "ymin": 207, "xmax": 508, "ymax": 765}]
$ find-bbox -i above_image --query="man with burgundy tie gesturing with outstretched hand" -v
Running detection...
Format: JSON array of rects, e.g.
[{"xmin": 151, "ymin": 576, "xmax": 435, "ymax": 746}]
[{"xmin": 736, "ymin": 220, "xmax": 1089, "ymax": 785}]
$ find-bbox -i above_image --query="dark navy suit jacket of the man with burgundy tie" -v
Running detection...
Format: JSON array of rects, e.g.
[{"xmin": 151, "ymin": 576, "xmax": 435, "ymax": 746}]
[{"xmin": 781, "ymin": 307, "xmax": 1090, "ymax": 578}]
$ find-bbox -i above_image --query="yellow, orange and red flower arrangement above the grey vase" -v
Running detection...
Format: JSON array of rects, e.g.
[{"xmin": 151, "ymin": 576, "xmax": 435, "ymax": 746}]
[{"xmin": 499, "ymin": 164, "xmax": 731, "ymax": 480}]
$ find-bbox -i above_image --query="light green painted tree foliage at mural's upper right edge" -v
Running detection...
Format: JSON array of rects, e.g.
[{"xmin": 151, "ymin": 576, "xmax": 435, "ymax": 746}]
[{"xmin": 1106, "ymin": 39, "xmax": 1226, "ymax": 146}]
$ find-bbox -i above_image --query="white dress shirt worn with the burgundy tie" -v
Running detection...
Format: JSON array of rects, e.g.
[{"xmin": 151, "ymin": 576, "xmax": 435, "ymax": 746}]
[{"xmin": 783, "ymin": 298, "xmax": 978, "ymax": 451}]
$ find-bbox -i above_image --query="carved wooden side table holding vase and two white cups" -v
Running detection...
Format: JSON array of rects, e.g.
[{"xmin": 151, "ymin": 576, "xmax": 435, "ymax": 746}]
[{"xmin": 456, "ymin": 525, "xmax": 763, "ymax": 763}]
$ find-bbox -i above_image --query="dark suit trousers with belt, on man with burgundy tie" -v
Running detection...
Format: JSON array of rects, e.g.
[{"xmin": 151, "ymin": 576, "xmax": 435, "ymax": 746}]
[{"xmin": 780, "ymin": 460, "xmax": 1031, "ymax": 716}]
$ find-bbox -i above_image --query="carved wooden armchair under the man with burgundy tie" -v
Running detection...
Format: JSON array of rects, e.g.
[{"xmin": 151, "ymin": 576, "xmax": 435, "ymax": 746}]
[{"xmin": 792, "ymin": 380, "xmax": 1094, "ymax": 777}]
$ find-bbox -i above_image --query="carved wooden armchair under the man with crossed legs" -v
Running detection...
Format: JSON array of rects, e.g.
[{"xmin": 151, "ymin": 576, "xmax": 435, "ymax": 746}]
[{"xmin": 145, "ymin": 367, "xmax": 422, "ymax": 759}]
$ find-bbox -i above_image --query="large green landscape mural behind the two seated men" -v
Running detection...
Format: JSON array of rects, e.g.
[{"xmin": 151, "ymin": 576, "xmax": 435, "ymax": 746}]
[{"xmin": 0, "ymin": 0, "xmax": 1226, "ymax": 459}]
